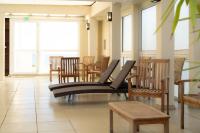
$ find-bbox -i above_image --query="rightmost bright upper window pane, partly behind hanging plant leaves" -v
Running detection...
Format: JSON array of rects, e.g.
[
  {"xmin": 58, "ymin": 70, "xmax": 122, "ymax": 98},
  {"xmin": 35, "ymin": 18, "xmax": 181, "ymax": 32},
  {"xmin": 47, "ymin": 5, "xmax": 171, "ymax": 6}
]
[{"xmin": 174, "ymin": 2, "xmax": 189, "ymax": 50}]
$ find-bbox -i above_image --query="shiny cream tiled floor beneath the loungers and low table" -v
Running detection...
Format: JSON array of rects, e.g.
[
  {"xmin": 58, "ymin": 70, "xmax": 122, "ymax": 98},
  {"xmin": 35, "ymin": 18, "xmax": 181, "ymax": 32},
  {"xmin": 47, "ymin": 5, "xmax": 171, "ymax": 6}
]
[{"xmin": 0, "ymin": 77, "xmax": 200, "ymax": 133}]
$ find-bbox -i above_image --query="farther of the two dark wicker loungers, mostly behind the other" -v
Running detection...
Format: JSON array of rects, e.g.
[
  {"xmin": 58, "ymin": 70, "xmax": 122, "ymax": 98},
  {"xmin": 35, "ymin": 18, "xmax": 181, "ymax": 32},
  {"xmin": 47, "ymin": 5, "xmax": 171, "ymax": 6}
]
[{"xmin": 49, "ymin": 60, "xmax": 119, "ymax": 91}]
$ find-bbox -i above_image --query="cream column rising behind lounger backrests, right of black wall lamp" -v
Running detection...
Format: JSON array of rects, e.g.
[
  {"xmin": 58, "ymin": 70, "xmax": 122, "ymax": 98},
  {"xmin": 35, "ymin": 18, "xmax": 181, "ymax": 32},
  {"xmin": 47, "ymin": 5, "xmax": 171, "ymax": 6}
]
[{"xmin": 110, "ymin": 3, "xmax": 121, "ymax": 76}]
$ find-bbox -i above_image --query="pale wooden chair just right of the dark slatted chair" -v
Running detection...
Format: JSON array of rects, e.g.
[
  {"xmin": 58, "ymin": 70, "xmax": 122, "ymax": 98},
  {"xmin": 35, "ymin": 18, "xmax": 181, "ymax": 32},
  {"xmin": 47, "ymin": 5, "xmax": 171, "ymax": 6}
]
[{"xmin": 78, "ymin": 56, "xmax": 95, "ymax": 82}]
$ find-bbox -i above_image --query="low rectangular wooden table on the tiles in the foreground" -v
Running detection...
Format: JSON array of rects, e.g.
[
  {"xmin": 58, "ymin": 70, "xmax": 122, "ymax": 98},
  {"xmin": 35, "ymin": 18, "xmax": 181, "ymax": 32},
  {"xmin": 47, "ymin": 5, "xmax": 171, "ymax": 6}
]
[{"xmin": 109, "ymin": 101, "xmax": 169, "ymax": 133}]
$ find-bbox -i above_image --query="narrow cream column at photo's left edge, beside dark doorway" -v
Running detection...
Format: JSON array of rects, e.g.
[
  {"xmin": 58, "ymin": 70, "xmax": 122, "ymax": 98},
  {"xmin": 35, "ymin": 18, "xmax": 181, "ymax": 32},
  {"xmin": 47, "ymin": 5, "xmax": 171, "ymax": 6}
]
[{"xmin": 0, "ymin": 13, "xmax": 5, "ymax": 81}]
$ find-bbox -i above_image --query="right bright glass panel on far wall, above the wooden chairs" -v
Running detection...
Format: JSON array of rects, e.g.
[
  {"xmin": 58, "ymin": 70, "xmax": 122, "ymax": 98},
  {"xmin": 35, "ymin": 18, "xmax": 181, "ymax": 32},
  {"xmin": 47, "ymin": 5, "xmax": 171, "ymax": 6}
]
[{"xmin": 39, "ymin": 21, "xmax": 79, "ymax": 73}]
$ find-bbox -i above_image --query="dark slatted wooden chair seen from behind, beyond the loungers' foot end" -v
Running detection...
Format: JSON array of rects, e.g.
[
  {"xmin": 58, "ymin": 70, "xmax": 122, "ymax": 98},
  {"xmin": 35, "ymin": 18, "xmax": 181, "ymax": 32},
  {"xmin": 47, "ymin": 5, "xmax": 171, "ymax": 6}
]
[{"xmin": 59, "ymin": 57, "xmax": 80, "ymax": 83}]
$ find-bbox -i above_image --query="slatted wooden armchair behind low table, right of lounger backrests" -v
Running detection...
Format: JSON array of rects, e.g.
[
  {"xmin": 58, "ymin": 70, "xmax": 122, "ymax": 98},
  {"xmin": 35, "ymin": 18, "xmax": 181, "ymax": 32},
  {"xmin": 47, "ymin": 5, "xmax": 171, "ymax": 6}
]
[{"xmin": 128, "ymin": 59, "xmax": 169, "ymax": 114}]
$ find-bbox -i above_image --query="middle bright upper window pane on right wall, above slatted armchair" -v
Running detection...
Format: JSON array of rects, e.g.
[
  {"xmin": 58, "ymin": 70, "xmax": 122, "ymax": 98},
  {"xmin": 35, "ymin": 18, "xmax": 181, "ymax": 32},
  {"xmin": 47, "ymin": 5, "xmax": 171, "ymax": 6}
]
[{"xmin": 142, "ymin": 6, "xmax": 156, "ymax": 50}]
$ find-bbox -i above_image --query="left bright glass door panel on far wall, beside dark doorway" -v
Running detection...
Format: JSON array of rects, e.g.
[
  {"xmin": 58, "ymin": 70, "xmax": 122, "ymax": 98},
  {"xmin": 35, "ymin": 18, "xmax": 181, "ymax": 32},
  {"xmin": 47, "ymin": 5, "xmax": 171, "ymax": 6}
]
[{"xmin": 12, "ymin": 21, "xmax": 37, "ymax": 74}]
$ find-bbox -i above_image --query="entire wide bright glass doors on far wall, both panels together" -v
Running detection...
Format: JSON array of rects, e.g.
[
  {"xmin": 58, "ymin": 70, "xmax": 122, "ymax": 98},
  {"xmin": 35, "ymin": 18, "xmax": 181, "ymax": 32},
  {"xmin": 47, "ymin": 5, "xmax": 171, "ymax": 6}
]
[{"xmin": 11, "ymin": 20, "xmax": 79, "ymax": 74}]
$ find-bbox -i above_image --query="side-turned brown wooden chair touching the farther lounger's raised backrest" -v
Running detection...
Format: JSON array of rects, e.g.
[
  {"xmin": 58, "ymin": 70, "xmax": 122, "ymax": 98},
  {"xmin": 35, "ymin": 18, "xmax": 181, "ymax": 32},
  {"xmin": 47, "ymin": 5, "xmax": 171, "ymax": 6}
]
[{"xmin": 88, "ymin": 56, "xmax": 110, "ymax": 82}]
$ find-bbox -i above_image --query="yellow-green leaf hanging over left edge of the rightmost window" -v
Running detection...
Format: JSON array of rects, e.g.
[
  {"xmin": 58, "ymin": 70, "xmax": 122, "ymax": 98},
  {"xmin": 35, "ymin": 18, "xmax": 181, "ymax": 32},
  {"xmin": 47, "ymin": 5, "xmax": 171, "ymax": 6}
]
[{"xmin": 172, "ymin": 0, "xmax": 184, "ymax": 34}]
